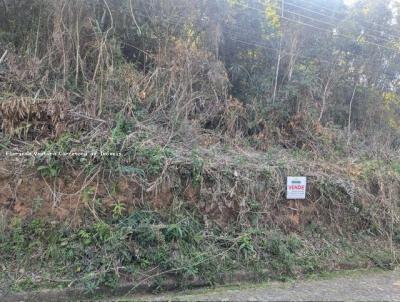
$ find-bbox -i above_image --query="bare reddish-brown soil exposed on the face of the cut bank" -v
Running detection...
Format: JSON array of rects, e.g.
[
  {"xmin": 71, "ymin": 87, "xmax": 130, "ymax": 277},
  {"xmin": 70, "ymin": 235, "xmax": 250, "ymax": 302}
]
[{"xmin": 0, "ymin": 161, "xmax": 318, "ymax": 230}]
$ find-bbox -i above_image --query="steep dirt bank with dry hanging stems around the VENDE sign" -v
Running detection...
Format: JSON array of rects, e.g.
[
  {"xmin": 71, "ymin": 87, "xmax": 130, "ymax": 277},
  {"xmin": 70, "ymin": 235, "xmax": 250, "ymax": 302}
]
[{"xmin": 0, "ymin": 149, "xmax": 399, "ymax": 231}]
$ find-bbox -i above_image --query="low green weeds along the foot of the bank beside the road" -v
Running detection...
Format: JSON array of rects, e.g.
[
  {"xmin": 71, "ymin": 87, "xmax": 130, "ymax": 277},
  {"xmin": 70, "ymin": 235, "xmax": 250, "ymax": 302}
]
[{"xmin": 0, "ymin": 205, "xmax": 398, "ymax": 292}]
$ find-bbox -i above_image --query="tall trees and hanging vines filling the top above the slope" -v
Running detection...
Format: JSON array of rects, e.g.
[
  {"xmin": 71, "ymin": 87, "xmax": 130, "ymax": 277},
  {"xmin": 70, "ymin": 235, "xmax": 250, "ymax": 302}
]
[{"xmin": 0, "ymin": 0, "xmax": 400, "ymax": 150}]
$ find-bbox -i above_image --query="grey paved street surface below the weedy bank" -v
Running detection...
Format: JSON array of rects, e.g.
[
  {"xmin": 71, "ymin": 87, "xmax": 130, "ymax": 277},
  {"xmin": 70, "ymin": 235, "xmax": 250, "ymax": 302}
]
[{"xmin": 134, "ymin": 271, "xmax": 400, "ymax": 301}]
